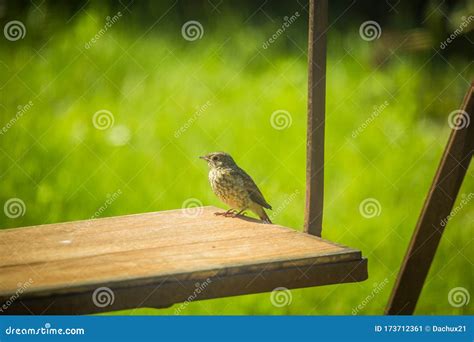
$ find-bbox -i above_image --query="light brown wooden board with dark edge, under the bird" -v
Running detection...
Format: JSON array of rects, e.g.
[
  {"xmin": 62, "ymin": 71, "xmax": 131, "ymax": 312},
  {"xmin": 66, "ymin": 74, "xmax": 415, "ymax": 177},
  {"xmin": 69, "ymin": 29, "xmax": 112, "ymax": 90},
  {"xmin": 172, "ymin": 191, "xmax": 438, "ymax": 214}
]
[{"xmin": 0, "ymin": 207, "xmax": 367, "ymax": 314}]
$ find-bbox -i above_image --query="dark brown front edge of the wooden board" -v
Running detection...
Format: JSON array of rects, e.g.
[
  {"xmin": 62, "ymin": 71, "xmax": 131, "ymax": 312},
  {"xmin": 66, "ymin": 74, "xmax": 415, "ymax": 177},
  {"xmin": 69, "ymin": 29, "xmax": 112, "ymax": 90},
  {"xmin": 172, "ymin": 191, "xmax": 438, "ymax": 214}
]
[{"xmin": 0, "ymin": 258, "xmax": 368, "ymax": 315}]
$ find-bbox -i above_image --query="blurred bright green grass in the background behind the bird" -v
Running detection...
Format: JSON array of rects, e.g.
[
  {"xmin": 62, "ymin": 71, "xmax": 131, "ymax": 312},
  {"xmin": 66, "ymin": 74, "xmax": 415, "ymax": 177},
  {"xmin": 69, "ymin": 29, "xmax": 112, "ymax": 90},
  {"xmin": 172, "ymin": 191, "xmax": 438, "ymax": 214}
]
[{"xmin": 0, "ymin": 6, "xmax": 474, "ymax": 315}]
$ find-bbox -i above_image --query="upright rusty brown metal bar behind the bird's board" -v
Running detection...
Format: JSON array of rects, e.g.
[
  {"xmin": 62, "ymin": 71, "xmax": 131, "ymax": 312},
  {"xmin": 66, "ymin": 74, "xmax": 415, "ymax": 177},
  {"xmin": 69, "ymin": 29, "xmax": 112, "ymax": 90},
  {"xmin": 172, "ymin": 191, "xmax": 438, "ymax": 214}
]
[{"xmin": 304, "ymin": 0, "xmax": 328, "ymax": 236}]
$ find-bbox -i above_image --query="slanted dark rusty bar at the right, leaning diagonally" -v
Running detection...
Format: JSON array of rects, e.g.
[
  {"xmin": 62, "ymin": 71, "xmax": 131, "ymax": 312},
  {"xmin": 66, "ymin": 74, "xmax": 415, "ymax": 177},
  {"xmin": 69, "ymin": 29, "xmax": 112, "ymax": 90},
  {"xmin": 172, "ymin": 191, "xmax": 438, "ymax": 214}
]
[{"xmin": 385, "ymin": 85, "xmax": 474, "ymax": 315}]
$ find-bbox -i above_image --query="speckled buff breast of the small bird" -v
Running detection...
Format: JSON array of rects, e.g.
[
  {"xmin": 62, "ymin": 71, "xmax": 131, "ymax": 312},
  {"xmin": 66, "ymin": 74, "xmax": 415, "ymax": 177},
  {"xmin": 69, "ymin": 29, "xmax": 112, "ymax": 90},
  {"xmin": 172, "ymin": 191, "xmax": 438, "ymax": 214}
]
[{"xmin": 209, "ymin": 169, "xmax": 250, "ymax": 209}]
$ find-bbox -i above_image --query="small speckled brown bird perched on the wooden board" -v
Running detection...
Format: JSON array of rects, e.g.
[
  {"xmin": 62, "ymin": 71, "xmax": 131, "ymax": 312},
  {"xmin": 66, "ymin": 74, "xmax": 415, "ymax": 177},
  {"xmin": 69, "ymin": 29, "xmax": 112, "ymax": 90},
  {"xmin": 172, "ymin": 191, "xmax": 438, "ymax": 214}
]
[{"xmin": 199, "ymin": 152, "xmax": 272, "ymax": 223}]
